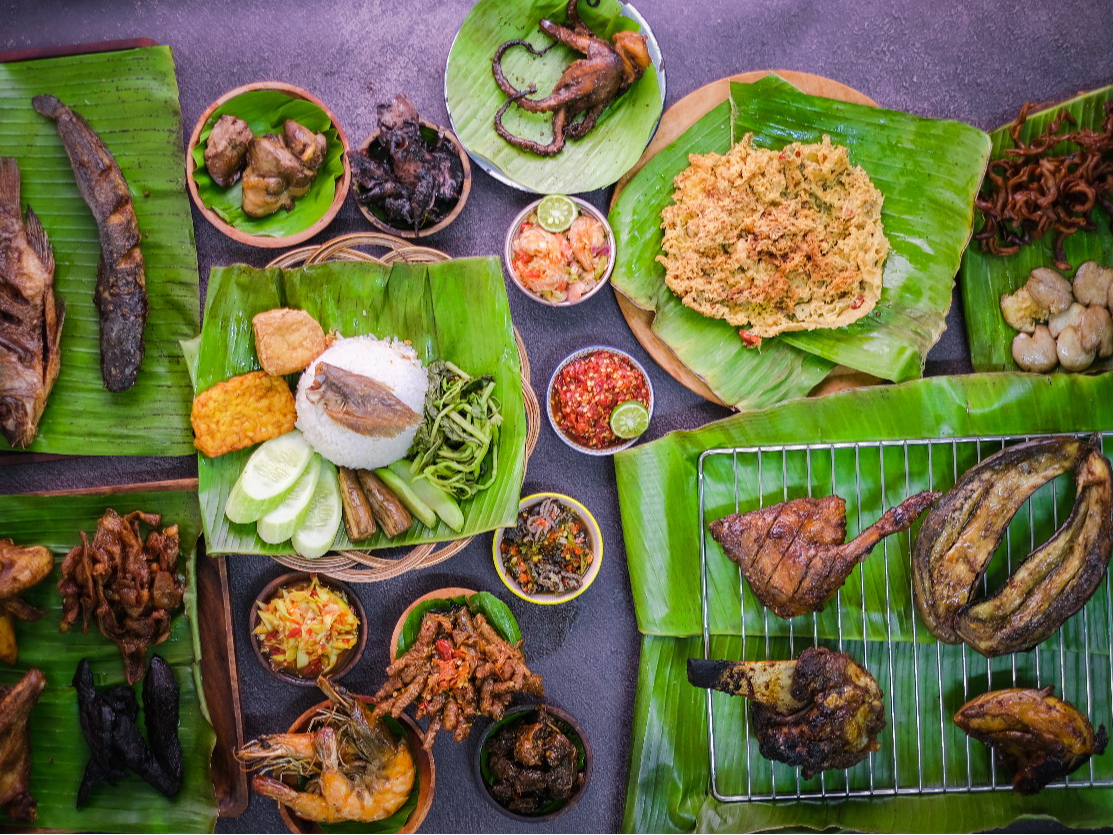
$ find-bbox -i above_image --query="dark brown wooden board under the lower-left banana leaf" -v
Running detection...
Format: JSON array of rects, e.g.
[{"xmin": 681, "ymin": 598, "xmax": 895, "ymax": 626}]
[{"xmin": 28, "ymin": 479, "xmax": 250, "ymax": 819}]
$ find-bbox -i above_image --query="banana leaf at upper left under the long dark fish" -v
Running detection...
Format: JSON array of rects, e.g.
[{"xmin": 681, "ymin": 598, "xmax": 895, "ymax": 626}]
[{"xmin": 0, "ymin": 47, "xmax": 199, "ymax": 455}]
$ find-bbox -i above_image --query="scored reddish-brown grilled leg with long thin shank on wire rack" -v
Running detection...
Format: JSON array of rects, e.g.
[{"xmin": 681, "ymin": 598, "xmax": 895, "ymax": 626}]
[{"xmin": 710, "ymin": 492, "xmax": 939, "ymax": 618}]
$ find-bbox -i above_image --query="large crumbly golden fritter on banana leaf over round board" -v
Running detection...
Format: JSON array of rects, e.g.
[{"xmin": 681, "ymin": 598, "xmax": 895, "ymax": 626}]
[{"xmin": 658, "ymin": 135, "xmax": 889, "ymax": 338}]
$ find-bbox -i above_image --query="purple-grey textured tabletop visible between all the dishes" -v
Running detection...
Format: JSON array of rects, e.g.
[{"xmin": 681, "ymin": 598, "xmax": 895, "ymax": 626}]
[{"xmin": 0, "ymin": 0, "xmax": 1113, "ymax": 832}]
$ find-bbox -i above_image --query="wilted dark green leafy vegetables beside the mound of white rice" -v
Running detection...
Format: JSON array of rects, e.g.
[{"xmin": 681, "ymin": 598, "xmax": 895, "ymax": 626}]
[{"xmin": 408, "ymin": 360, "xmax": 502, "ymax": 499}]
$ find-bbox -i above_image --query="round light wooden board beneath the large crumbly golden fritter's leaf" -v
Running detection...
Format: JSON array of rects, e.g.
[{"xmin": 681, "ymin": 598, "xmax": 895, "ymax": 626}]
[{"xmin": 611, "ymin": 70, "xmax": 880, "ymax": 409}]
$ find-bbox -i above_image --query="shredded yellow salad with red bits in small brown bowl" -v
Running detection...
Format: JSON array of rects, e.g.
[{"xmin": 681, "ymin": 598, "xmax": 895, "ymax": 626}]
[{"xmin": 254, "ymin": 574, "xmax": 359, "ymax": 678}]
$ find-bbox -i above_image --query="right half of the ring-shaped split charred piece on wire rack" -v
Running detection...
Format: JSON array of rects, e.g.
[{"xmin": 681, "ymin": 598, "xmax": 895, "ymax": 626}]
[{"xmin": 955, "ymin": 449, "xmax": 1113, "ymax": 658}]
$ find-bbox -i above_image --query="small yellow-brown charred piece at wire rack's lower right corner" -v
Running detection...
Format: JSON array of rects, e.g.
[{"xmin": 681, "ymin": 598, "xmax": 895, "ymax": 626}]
[{"xmin": 955, "ymin": 687, "xmax": 1109, "ymax": 795}]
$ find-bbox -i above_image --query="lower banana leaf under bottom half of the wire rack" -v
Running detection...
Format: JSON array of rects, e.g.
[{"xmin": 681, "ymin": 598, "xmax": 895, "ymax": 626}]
[{"xmin": 622, "ymin": 636, "xmax": 1113, "ymax": 833}]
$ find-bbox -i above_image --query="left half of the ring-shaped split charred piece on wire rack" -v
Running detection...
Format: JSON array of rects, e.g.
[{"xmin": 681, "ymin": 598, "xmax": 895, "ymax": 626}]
[{"xmin": 912, "ymin": 436, "xmax": 1087, "ymax": 644}]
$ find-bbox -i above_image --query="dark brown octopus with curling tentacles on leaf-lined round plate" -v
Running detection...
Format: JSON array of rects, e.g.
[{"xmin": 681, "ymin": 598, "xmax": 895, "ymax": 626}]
[{"xmin": 492, "ymin": 0, "xmax": 650, "ymax": 157}]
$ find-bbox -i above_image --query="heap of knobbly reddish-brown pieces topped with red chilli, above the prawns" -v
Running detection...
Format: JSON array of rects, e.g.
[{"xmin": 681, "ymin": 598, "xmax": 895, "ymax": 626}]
[{"xmin": 374, "ymin": 607, "xmax": 545, "ymax": 749}]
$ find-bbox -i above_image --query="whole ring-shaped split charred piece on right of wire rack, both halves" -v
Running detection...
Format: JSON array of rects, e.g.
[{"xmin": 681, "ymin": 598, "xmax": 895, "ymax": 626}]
[{"xmin": 913, "ymin": 436, "xmax": 1113, "ymax": 657}]
